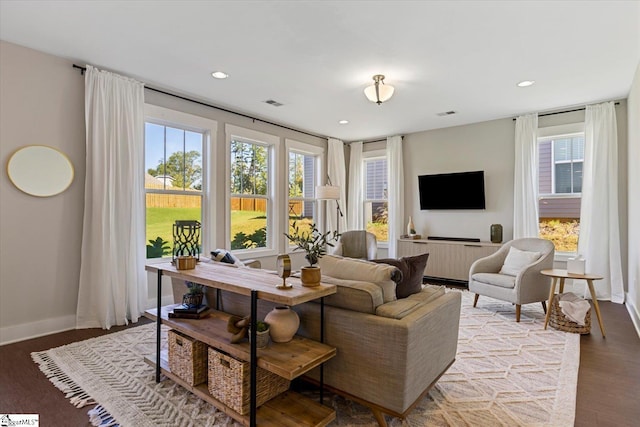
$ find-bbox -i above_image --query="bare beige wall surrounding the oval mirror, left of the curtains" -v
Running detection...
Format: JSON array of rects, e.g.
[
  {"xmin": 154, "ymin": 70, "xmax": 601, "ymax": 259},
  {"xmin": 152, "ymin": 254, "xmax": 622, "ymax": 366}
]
[{"xmin": 0, "ymin": 41, "xmax": 85, "ymax": 343}]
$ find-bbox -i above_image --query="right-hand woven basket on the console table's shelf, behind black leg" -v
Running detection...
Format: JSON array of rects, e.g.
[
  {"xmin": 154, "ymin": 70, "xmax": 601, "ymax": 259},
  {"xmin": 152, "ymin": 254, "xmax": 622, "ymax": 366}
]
[{"xmin": 208, "ymin": 347, "xmax": 289, "ymax": 415}]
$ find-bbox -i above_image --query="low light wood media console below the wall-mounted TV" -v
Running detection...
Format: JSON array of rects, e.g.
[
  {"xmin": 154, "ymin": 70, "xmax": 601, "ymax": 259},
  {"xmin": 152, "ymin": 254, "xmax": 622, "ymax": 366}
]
[{"xmin": 398, "ymin": 239, "xmax": 502, "ymax": 282}]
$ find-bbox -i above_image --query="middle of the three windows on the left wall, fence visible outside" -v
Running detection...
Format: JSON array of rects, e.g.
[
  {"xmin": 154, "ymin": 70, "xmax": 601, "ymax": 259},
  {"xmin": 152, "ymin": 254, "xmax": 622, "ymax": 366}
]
[{"xmin": 227, "ymin": 125, "xmax": 279, "ymax": 250}]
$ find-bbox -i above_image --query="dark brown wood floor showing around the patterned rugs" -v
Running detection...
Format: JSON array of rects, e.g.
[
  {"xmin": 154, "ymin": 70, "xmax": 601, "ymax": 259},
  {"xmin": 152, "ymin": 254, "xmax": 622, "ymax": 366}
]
[{"xmin": 0, "ymin": 302, "xmax": 640, "ymax": 427}]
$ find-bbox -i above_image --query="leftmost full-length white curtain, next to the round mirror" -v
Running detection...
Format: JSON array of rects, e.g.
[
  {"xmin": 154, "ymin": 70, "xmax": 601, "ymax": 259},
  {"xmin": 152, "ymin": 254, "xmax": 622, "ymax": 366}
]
[{"xmin": 76, "ymin": 66, "xmax": 147, "ymax": 329}]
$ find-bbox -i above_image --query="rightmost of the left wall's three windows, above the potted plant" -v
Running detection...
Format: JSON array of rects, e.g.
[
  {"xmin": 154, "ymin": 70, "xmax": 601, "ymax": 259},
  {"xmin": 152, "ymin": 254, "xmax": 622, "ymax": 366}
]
[{"xmin": 287, "ymin": 140, "xmax": 323, "ymax": 242}]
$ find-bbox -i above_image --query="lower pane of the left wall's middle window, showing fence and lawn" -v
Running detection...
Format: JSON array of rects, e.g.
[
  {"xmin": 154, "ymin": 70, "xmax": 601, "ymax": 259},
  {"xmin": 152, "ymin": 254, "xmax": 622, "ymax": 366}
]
[{"xmin": 231, "ymin": 197, "xmax": 268, "ymax": 250}]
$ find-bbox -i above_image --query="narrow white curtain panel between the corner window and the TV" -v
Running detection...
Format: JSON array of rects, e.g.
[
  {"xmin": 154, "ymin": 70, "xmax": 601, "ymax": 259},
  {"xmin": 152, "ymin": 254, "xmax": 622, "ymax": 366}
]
[{"xmin": 387, "ymin": 136, "xmax": 405, "ymax": 258}]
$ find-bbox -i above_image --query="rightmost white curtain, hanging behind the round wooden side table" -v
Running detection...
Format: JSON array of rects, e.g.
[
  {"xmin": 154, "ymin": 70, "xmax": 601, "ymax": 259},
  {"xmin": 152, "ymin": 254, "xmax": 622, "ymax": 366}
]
[{"xmin": 578, "ymin": 102, "xmax": 624, "ymax": 303}]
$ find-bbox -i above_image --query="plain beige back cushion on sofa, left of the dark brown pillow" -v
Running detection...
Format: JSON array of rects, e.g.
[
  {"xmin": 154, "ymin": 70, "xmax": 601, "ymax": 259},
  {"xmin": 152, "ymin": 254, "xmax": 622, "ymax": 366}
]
[{"xmin": 318, "ymin": 255, "xmax": 400, "ymax": 302}]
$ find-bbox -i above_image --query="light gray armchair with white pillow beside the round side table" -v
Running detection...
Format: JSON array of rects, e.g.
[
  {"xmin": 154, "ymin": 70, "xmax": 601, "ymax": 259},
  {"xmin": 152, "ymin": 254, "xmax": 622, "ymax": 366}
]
[{"xmin": 469, "ymin": 238, "xmax": 555, "ymax": 322}]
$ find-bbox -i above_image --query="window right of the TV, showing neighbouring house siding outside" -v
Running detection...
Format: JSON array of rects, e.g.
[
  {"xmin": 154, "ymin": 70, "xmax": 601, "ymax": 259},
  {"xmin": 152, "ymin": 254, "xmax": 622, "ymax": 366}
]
[{"xmin": 538, "ymin": 125, "xmax": 584, "ymax": 252}]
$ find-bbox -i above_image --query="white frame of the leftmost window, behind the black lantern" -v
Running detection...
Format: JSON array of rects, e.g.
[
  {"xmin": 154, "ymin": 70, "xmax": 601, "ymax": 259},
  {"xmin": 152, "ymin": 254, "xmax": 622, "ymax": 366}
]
[{"xmin": 142, "ymin": 104, "xmax": 218, "ymax": 262}]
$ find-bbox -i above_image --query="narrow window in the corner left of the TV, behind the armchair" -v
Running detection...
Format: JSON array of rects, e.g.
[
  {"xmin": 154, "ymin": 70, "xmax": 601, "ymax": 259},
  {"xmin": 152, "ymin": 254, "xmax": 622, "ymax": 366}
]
[{"xmin": 363, "ymin": 156, "xmax": 389, "ymax": 243}]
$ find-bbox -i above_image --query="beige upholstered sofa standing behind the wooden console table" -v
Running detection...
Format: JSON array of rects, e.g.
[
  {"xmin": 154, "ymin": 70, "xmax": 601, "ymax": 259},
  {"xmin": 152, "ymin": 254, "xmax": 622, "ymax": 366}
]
[{"xmin": 174, "ymin": 256, "xmax": 461, "ymax": 426}]
